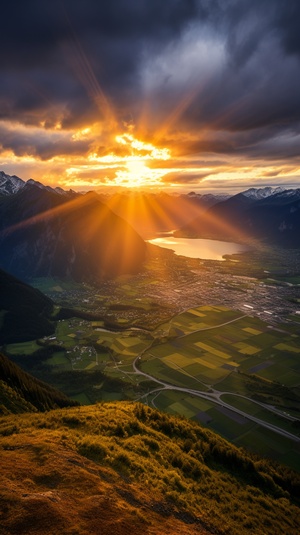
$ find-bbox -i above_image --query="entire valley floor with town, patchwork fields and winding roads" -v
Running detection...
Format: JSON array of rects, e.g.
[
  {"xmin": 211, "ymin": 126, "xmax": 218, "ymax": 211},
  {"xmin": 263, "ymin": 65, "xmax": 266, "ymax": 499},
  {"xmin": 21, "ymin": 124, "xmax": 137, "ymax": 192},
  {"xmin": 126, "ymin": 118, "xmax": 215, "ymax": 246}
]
[{"xmin": 6, "ymin": 248, "xmax": 300, "ymax": 469}]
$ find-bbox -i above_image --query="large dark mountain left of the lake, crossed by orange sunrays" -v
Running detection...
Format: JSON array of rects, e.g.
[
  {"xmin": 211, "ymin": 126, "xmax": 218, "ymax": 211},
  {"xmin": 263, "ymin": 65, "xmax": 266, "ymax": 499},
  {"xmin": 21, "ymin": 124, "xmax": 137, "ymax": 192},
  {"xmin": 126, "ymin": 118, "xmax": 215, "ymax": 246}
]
[{"xmin": 0, "ymin": 185, "xmax": 146, "ymax": 281}]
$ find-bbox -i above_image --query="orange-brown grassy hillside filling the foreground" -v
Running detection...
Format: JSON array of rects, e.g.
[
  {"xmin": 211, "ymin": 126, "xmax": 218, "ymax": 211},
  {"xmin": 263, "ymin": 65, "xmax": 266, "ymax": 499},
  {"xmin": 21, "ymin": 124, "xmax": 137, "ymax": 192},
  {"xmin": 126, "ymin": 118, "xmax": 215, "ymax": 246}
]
[{"xmin": 0, "ymin": 402, "xmax": 300, "ymax": 535}]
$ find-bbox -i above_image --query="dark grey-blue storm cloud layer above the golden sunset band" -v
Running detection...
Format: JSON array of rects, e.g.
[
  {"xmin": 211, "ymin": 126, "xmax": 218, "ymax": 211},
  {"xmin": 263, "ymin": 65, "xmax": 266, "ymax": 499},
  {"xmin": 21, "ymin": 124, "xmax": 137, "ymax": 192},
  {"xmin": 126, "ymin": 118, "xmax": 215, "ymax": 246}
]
[{"xmin": 0, "ymin": 0, "xmax": 300, "ymax": 162}]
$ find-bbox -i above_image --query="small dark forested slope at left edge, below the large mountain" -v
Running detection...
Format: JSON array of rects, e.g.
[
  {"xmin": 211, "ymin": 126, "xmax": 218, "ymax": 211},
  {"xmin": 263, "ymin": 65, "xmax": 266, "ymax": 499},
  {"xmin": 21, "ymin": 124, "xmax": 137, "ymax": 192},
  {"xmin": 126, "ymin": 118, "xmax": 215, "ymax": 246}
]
[{"xmin": 0, "ymin": 269, "xmax": 54, "ymax": 345}]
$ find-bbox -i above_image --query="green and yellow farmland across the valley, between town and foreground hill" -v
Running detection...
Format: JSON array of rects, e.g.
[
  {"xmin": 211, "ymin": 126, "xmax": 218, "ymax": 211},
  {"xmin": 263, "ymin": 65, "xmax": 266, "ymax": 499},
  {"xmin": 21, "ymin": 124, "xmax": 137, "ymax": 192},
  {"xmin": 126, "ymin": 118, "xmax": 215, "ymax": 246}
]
[{"xmin": 8, "ymin": 306, "xmax": 300, "ymax": 468}]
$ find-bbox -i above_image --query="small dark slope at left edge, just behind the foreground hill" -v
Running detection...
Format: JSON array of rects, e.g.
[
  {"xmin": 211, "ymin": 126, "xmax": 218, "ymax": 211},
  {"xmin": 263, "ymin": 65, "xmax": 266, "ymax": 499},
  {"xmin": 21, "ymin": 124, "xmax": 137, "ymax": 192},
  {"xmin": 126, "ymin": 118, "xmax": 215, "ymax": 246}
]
[{"xmin": 0, "ymin": 353, "xmax": 77, "ymax": 414}]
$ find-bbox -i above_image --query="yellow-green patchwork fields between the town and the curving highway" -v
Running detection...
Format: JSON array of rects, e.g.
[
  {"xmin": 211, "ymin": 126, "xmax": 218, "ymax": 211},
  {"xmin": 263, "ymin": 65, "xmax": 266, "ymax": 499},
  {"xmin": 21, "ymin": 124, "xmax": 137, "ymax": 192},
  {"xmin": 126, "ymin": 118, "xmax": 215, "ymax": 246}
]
[{"xmin": 142, "ymin": 307, "xmax": 300, "ymax": 389}]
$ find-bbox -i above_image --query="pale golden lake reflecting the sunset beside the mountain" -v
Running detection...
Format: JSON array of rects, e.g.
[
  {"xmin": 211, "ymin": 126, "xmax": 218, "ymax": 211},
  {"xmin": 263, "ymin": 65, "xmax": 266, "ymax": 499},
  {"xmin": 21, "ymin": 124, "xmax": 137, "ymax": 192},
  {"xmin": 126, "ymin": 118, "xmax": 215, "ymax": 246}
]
[{"xmin": 148, "ymin": 236, "xmax": 249, "ymax": 260}]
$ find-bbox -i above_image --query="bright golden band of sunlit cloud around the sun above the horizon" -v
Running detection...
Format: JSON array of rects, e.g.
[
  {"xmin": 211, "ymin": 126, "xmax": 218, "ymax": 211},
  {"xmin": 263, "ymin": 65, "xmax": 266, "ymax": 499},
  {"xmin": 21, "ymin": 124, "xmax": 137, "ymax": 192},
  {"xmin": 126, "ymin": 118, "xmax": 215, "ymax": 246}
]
[{"xmin": 0, "ymin": 121, "xmax": 299, "ymax": 193}]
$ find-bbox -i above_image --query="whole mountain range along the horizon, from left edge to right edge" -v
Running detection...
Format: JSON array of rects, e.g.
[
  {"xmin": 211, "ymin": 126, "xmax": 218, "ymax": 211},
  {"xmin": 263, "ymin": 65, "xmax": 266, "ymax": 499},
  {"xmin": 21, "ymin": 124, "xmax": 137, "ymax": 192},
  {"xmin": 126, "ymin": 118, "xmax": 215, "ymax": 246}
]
[{"xmin": 0, "ymin": 171, "xmax": 300, "ymax": 253}]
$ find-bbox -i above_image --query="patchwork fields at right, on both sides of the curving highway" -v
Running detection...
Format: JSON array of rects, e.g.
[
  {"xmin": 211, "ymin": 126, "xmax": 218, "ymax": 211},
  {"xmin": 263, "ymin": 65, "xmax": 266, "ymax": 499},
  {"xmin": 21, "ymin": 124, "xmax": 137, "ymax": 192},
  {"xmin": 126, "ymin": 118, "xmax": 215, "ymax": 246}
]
[{"xmin": 140, "ymin": 307, "xmax": 300, "ymax": 468}]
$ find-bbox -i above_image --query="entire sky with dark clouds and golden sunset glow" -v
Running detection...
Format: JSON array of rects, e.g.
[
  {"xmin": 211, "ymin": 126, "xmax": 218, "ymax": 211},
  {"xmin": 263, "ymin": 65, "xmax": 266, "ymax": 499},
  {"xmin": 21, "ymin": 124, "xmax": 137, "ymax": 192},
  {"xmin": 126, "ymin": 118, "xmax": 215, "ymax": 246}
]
[{"xmin": 0, "ymin": 0, "xmax": 300, "ymax": 193}]
